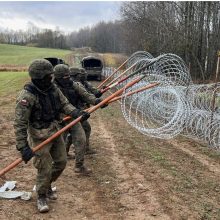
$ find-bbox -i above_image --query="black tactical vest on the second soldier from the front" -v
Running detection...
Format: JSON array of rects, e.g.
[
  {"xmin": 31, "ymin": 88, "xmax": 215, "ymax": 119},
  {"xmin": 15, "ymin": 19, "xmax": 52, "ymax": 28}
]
[{"xmin": 56, "ymin": 81, "xmax": 79, "ymax": 108}]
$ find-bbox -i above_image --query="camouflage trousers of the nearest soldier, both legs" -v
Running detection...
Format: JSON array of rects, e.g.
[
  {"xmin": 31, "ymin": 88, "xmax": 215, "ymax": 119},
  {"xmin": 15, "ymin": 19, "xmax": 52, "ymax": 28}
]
[{"xmin": 31, "ymin": 136, "xmax": 67, "ymax": 195}]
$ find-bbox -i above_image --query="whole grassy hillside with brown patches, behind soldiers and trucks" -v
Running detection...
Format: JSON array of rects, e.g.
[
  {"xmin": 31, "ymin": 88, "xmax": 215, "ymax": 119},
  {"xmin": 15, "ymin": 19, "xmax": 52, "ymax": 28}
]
[{"xmin": 0, "ymin": 44, "xmax": 126, "ymax": 71}]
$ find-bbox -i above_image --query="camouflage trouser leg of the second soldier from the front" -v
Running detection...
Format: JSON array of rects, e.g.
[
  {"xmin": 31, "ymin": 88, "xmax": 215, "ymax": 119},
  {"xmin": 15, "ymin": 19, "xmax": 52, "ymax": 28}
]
[{"xmin": 70, "ymin": 123, "xmax": 86, "ymax": 167}]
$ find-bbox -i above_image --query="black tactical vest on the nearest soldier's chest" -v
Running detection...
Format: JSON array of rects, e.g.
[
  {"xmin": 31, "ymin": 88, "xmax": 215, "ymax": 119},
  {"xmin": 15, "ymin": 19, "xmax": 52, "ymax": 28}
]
[{"xmin": 24, "ymin": 83, "xmax": 62, "ymax": 127}]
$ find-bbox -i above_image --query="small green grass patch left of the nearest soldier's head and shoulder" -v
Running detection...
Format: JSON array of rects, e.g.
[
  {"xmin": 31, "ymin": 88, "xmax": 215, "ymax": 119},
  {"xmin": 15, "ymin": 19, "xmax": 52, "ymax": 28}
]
[{"xmin": 0, "ymin": 72, "xmax": 29, "ymax": 98}]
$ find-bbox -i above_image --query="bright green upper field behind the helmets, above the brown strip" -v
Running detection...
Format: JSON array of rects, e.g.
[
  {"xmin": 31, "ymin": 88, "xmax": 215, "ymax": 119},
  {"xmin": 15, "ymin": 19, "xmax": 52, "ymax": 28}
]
[{"xmin": 0, "ymin": 44, "xmax": 71, "ymax": 66}]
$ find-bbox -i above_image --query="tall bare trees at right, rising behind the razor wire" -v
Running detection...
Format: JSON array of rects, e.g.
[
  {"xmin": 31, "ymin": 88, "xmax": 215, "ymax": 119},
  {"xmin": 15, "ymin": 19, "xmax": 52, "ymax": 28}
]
[{"xmin": 121, "ymin": 1, "xmax": 220, "ymax": 81}]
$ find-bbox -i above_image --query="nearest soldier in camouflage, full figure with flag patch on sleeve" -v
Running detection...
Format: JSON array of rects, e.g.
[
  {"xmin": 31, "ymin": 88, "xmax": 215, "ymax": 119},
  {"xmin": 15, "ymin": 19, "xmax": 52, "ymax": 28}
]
[{"xmin": 14, "ymin": 59, "xmax": 89, "ymax": 213}]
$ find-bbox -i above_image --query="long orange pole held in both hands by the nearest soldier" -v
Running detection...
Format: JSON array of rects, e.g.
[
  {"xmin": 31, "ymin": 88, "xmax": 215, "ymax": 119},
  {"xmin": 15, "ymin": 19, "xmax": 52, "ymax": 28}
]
[{"xmin": 0, "ymin": 76, "xmax": 145, "ymax": 177}]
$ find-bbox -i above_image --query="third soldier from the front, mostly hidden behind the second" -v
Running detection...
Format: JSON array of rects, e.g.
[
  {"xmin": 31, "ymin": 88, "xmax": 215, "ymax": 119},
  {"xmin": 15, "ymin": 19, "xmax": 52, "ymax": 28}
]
[{"xmin": 70, "ymin": 67, "xmax": 107, "ymax": 154}]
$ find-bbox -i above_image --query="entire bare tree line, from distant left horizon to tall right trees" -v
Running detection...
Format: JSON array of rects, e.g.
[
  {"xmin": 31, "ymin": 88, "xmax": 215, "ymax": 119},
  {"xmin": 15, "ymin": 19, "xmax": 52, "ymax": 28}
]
[{"xmin": 0, "ymin": 1, "xmax": 220, "ymax": 80}]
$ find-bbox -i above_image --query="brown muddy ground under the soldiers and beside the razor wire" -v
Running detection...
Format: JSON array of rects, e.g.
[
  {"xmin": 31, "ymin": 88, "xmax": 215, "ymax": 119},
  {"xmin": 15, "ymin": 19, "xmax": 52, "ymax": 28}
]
[{"xmin": 0, "ymin": 81, "xmax": 220, "ymax": 220}]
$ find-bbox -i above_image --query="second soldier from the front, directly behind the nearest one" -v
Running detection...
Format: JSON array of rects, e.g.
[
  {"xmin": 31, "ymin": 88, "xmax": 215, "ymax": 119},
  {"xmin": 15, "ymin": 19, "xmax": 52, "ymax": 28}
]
[{"xmin": 54, "ymin": 64, "xmax": 102, "ymax": 175}]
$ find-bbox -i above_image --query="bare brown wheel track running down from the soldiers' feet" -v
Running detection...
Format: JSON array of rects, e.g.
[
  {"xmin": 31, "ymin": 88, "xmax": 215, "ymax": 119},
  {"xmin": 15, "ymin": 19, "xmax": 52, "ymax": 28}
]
[{"xmin": 94, "ymin": 114, "xmax": 170, "ymax": 220}]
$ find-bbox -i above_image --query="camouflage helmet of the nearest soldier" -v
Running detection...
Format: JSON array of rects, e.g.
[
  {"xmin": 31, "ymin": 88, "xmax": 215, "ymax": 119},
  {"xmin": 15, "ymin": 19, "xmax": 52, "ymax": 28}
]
[{"xmin": 28, "ymin": 59, "xmax": 53, "ymax": 79}]
